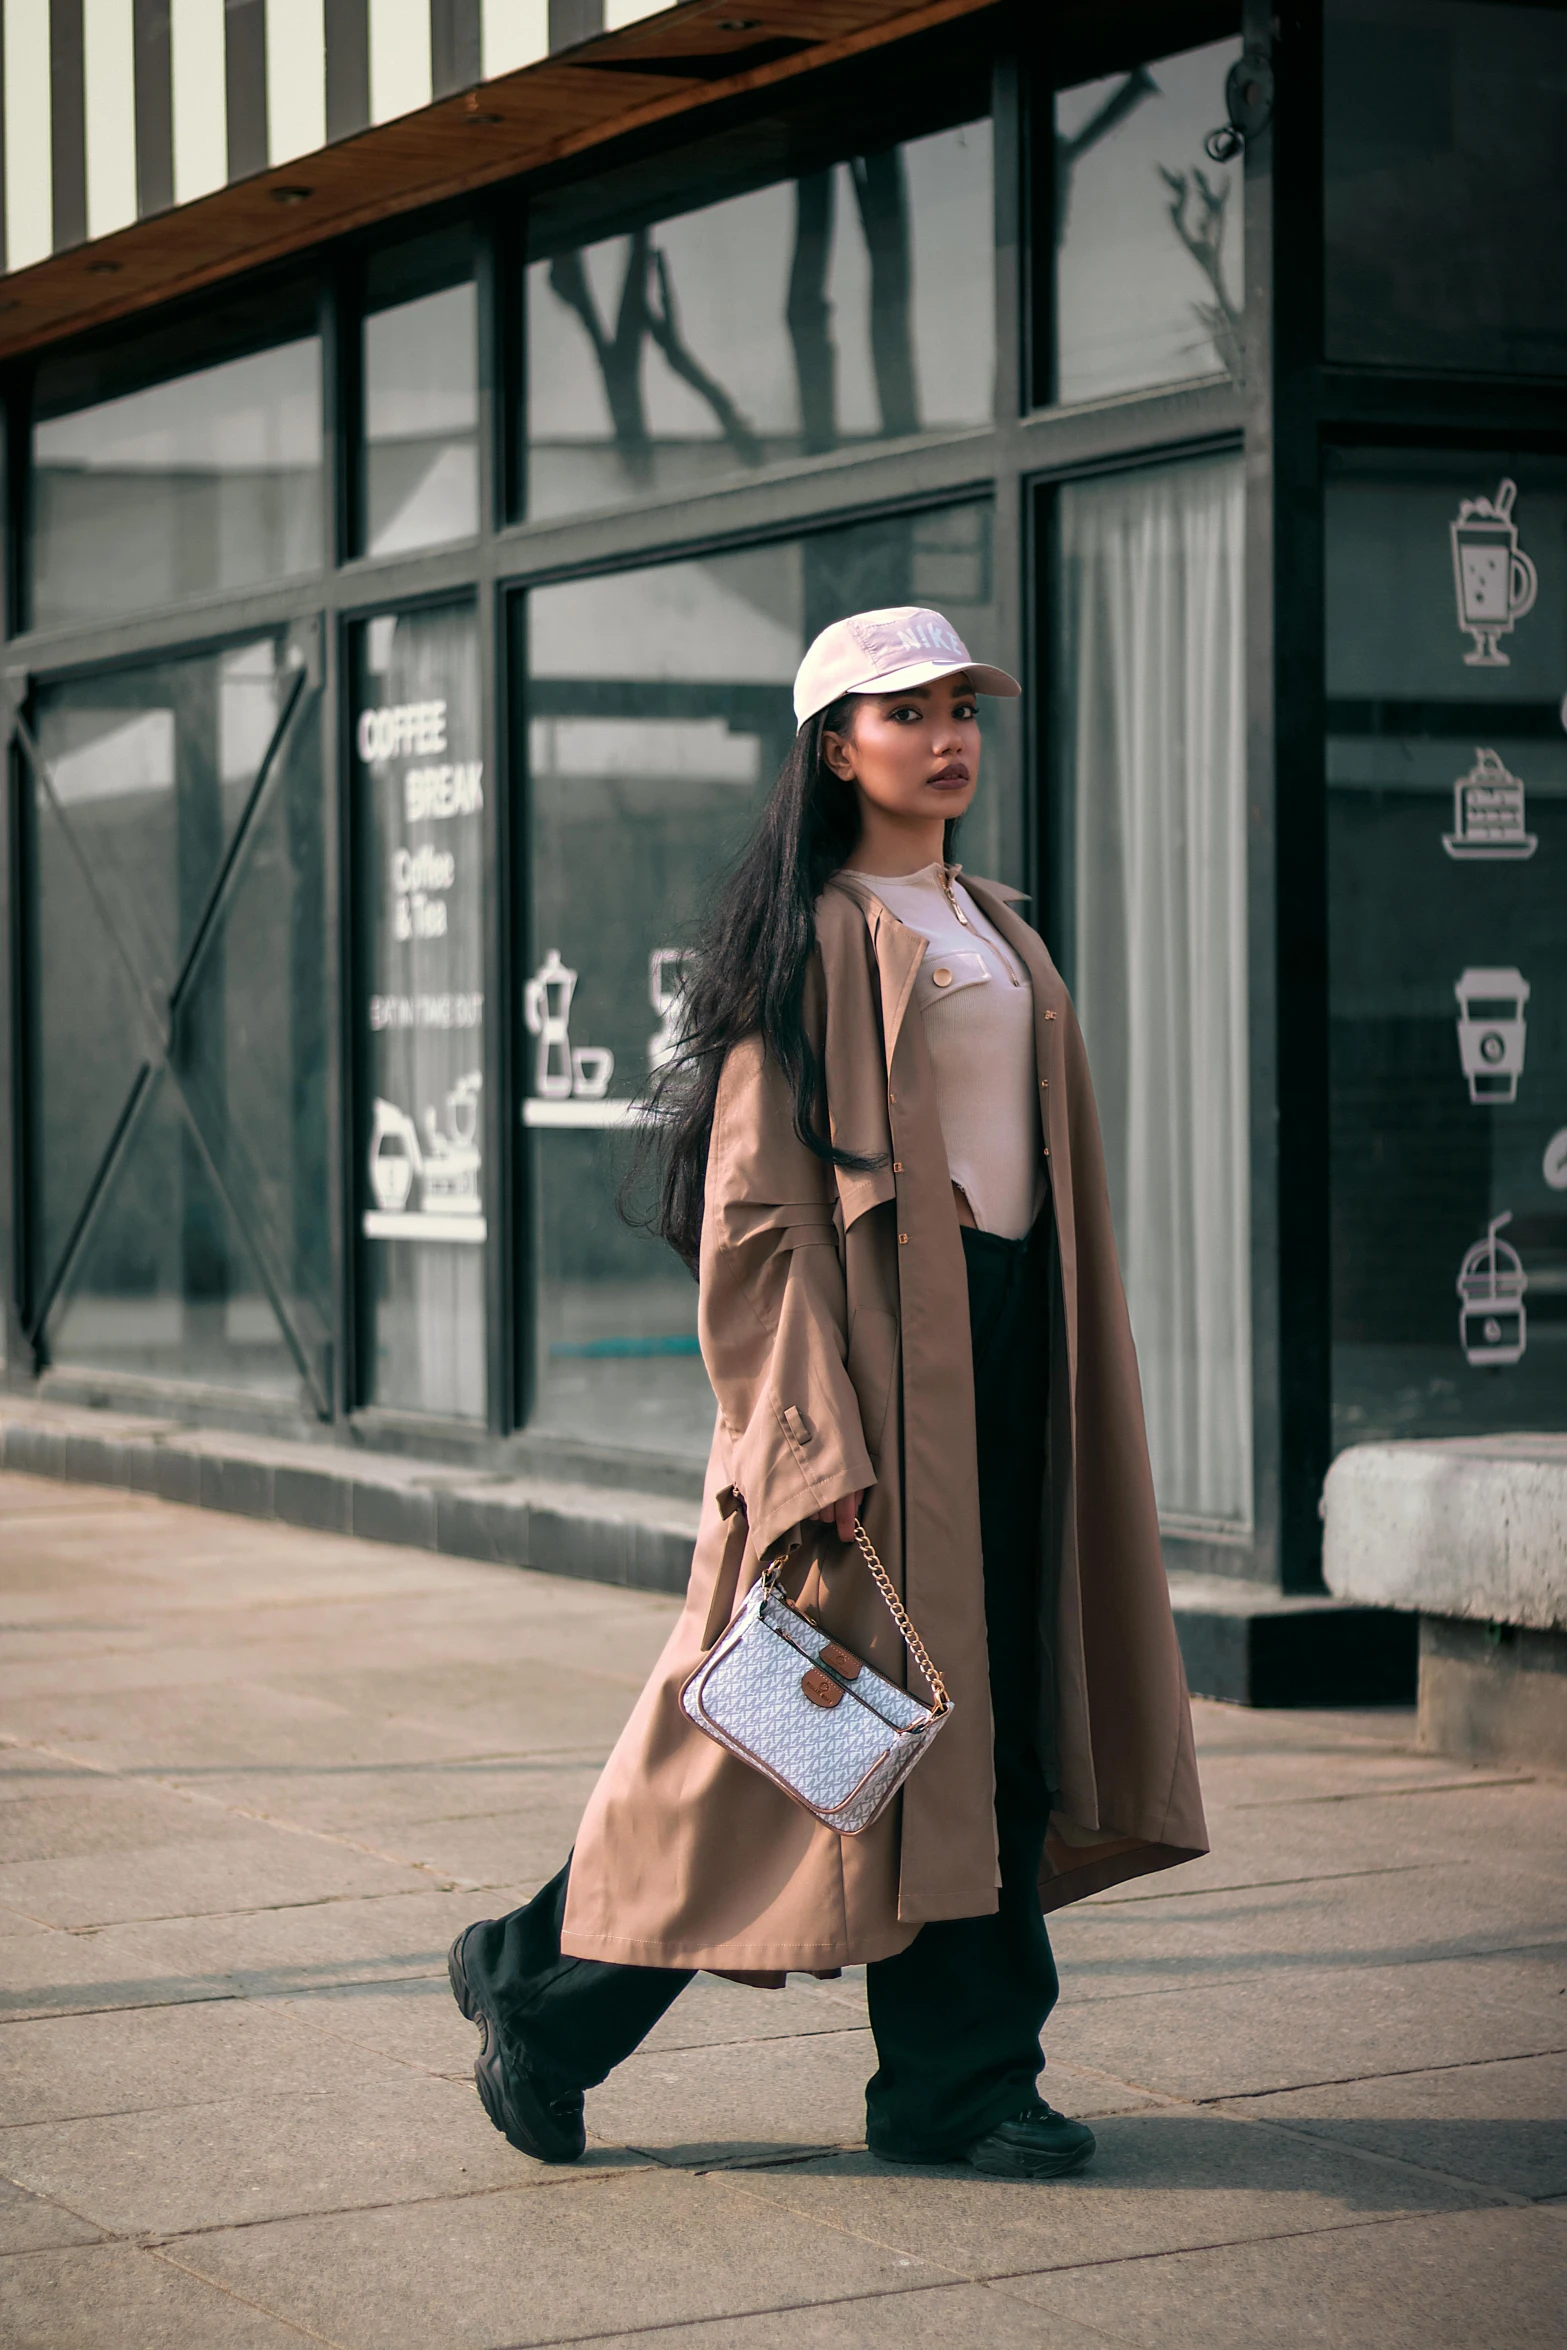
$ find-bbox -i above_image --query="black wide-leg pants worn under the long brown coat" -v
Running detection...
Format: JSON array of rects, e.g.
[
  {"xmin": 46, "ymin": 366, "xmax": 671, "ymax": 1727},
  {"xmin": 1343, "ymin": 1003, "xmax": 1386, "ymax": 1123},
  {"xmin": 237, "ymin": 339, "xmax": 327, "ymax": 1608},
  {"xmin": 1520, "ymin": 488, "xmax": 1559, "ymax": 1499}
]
[{"xmin": 465, "ymin": 1215, "xmax": 1057, "ymax": 2160}]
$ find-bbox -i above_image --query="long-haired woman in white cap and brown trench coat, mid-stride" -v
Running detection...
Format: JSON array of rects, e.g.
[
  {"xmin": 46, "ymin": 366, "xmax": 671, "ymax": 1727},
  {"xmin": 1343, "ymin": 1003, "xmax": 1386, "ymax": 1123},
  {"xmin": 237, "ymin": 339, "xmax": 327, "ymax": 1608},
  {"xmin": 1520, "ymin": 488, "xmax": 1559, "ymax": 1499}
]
[{"xmin": 451, "ymin": 609, "xmax": 1205, "ymax": 2178}]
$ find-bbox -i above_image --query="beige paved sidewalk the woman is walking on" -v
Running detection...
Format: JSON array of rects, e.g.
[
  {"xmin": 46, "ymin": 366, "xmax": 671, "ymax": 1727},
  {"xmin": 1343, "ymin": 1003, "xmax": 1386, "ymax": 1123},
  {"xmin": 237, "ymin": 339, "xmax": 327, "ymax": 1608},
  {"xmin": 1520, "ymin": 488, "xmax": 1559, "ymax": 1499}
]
[{"xmin": 0, "ymin": 1476, "xmax": 1567, "ymax": 2350}]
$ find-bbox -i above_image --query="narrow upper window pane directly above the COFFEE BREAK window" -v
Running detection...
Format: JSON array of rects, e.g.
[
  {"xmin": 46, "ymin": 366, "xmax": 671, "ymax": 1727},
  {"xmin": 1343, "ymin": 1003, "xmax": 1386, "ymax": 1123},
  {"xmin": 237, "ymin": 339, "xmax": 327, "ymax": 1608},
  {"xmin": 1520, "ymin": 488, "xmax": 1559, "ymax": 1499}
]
[{"xmin": 362, "ymin": 235, "xmax": 479, "ymax": 555}]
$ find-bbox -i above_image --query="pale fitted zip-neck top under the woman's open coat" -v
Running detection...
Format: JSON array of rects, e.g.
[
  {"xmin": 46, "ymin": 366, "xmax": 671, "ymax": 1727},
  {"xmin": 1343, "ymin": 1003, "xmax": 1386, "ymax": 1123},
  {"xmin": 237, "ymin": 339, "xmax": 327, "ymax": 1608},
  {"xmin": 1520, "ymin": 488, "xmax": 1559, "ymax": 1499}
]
[{"xmin": 846, "ymin": 865, "xmax": 1045, "ymax": 1241}]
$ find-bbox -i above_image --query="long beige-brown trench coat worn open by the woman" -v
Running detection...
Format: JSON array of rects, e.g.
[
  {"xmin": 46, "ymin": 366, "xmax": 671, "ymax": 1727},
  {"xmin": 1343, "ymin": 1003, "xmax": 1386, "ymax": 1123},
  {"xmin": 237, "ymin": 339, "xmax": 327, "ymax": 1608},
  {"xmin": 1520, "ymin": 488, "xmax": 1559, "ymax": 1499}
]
[{"xmin": 561, "ymin": 874, "xmax": 1208, "ymax": 1974}]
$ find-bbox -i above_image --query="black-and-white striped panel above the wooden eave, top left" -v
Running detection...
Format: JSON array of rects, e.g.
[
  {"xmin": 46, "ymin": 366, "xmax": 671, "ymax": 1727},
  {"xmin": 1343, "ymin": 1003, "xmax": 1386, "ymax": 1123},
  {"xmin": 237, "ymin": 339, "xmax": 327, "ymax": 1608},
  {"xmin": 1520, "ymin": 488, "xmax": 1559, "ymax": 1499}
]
[{"xmin": 0, "ymin": 0, "xmax": 670, "ymax": 270}]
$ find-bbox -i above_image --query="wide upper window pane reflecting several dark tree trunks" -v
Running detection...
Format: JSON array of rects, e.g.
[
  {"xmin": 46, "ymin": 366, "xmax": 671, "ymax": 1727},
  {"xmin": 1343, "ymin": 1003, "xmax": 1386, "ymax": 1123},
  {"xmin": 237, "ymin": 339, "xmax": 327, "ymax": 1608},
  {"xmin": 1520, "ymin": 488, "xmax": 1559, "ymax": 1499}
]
[{"xmin": 526, "ymin": 120, "xmax": 996, "ymax": 519}]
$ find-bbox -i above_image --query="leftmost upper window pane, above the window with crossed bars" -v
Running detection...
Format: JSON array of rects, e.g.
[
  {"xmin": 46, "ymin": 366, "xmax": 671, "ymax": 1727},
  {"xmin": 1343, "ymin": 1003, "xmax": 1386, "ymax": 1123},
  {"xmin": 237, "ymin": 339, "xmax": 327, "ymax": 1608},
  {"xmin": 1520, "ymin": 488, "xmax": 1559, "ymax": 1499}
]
[{"xmin": 28, "ymin": 334, "xmax": 322, "ymax": 627}]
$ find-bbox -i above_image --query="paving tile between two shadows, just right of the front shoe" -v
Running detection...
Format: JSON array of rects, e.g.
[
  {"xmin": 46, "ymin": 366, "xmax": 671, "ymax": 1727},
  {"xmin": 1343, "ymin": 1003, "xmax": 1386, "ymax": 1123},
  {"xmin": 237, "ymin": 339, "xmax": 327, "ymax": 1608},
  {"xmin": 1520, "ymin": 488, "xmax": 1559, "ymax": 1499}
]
[{"xmin": 1045, "ymin": 1951, "xmax": 1567, "ymax": 2099}]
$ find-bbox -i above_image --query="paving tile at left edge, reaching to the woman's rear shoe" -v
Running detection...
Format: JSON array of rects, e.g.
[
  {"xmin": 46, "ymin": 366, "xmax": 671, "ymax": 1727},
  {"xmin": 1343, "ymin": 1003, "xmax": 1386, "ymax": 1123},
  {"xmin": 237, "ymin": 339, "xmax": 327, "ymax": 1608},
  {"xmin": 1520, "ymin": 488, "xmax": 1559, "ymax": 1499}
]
[{"xmin": 0, "ymin": 2061, "xmax": 625, "ymax": 2235}]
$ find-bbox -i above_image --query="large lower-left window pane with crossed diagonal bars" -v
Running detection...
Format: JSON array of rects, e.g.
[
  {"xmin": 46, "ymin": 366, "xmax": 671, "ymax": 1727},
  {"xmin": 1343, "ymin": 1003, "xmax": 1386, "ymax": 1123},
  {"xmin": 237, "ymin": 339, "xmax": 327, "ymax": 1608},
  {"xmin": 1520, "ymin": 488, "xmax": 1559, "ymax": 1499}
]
[{"xmin": 28, "ymin": 635, "xmax": 331, "ymax": 1410}]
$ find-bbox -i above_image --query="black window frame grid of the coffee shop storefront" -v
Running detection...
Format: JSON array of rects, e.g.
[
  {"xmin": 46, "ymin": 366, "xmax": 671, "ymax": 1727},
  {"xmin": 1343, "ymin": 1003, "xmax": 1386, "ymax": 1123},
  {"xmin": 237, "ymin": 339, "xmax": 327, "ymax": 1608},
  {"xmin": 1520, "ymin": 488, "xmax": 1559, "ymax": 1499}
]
[{"xmin": 0, "ymin": 0, "xmax": 1562, "ymax": 1591}]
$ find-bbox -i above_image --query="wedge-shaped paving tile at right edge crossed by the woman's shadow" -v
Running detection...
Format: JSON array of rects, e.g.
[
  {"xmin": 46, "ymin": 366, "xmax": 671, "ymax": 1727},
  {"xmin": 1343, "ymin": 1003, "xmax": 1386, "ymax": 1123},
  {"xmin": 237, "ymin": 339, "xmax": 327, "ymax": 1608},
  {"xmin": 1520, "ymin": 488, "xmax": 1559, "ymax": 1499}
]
[{"xmin": 1226, "ymin": 2054, "xmax": 1567, "ymax": 2195}]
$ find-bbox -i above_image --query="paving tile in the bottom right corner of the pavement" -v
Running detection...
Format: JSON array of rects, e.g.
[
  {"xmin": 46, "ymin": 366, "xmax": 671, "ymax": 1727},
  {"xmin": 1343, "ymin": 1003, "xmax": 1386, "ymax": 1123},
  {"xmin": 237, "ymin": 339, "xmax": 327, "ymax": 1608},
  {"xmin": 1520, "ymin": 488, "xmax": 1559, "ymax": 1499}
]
[{"xmin": 998, "ymin": 2209, "xmax": 1567, "ymax": 2350}]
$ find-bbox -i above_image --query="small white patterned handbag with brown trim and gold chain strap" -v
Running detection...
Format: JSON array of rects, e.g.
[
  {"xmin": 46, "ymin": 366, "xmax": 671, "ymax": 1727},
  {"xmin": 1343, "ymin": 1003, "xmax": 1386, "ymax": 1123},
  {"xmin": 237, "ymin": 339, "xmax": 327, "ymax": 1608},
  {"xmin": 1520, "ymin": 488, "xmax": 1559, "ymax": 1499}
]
[{"xmin": 681, "ymin": 1518, "xmax": 951, "ymax": 1835}]
